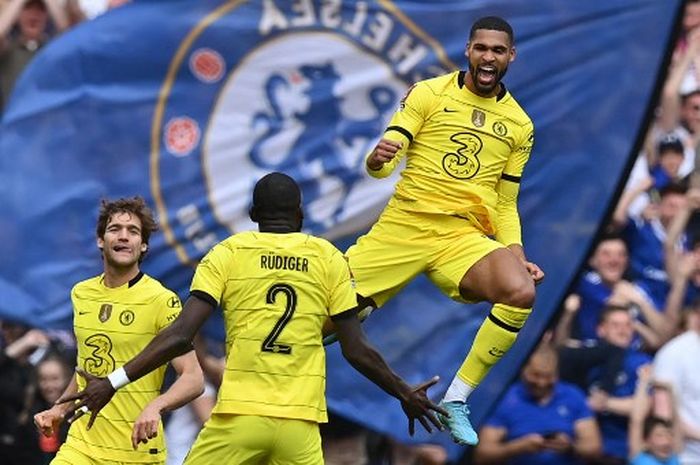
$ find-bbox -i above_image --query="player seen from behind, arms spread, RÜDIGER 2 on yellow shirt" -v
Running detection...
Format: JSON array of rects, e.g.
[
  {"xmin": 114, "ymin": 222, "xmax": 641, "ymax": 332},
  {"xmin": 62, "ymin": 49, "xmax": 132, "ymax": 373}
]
[{"xmin": 58, "ymin": 173, "xmax": 447, "ymax": 465}]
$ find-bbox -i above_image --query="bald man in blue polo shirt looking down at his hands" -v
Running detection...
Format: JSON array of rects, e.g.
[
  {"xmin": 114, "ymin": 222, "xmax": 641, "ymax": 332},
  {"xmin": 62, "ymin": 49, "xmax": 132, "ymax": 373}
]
[{"xmin": 474, "ymin": 347, "xmax": 601, "ymax": 465}]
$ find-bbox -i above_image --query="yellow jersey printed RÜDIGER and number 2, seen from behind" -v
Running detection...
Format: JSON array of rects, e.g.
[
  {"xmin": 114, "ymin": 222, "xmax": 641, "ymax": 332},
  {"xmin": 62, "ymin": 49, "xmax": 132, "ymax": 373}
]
[{"xmin": 190, "ymin": 231, "xmax": 357, "ymax": 423}]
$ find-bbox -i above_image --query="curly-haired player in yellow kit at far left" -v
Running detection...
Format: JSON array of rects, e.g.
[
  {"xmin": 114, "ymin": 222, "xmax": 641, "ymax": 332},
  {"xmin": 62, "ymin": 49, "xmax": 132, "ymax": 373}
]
[{"xmin": 34, "ymin": 197, "xmax": 204, "ymax": 465}]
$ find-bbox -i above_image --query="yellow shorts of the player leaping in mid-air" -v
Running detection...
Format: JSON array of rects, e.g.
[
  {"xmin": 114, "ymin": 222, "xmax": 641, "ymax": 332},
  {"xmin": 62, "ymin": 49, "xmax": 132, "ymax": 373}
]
[{"xmin": 345, "ymin": 207, "xmax": 505, "ymax": 306}]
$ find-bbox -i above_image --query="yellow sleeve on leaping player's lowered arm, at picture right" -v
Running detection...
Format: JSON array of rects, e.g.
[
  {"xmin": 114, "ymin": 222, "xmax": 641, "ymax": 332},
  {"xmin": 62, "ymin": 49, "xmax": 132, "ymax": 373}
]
[{"xmin": 496, "ymin": 122, "xmax": 534, "ymax": 245}]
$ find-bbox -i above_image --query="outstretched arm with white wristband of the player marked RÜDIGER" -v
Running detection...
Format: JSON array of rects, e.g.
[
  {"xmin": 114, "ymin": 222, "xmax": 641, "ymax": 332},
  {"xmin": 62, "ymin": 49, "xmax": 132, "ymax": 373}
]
[{"xmin": 56, "ymin": 295, "xmax": 214, "ymax": 428}]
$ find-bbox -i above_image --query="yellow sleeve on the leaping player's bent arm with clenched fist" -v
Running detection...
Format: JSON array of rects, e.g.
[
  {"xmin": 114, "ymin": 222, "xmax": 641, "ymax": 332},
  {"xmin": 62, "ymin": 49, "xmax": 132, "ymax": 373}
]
[{"xmin": 365, "ymin": 83, "xmax": 432, "ymax": 178}]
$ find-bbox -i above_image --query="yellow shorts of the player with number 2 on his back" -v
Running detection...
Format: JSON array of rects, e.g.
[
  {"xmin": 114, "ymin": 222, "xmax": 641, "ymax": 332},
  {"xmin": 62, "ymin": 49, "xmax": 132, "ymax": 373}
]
[{"xmin": 184, "ymin": 414, "xmax": 323, "ymax": 465}]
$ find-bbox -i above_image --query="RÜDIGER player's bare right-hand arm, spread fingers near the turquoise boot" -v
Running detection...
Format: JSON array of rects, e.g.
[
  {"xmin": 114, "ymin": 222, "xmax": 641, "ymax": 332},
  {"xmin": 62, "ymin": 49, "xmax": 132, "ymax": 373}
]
[{"xmin": 333, "ymin": 309, "xmax": 448, "ymax": 435}]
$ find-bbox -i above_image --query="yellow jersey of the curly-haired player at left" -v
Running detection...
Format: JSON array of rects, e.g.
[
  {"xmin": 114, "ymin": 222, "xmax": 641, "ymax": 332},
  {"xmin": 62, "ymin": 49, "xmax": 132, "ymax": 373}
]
[{"xmin": 67, "ymin": 273, "xmax": 182, "ymax": 462}]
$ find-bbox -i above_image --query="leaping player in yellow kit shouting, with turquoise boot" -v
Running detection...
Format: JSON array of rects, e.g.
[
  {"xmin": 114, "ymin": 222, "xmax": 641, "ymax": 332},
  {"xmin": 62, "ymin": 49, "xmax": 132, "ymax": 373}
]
[{"xmin": 346, "ymin": 16, "xmax": 544, "ymax": 445}]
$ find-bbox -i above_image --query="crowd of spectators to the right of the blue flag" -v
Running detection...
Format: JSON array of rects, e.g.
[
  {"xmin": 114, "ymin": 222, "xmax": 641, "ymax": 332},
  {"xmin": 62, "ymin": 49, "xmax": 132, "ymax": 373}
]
[{"xmin": 474, "ymin": 0, "xmax": 700, "ymax": 465}]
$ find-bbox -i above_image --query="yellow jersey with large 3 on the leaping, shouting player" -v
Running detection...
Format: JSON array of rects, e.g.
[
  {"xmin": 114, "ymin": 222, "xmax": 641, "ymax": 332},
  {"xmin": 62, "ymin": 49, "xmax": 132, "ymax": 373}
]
[{"xmin": 367, "ymin": 71, "xmax": 534, "ymax": 245}]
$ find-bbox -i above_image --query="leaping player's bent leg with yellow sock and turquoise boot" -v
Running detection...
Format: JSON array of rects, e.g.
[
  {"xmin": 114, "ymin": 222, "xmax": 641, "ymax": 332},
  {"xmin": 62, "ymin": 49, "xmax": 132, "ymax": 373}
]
[{"xmin": 440, "ymin": 248, "xmax": 535, "ymax": 445}]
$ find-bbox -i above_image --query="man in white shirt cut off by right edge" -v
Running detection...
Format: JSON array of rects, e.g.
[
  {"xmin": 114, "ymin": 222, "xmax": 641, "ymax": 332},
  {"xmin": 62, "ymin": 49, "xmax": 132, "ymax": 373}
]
[{"xmin": 654, "ymin": 302, "xmax": 700, "ymax": 465}]
